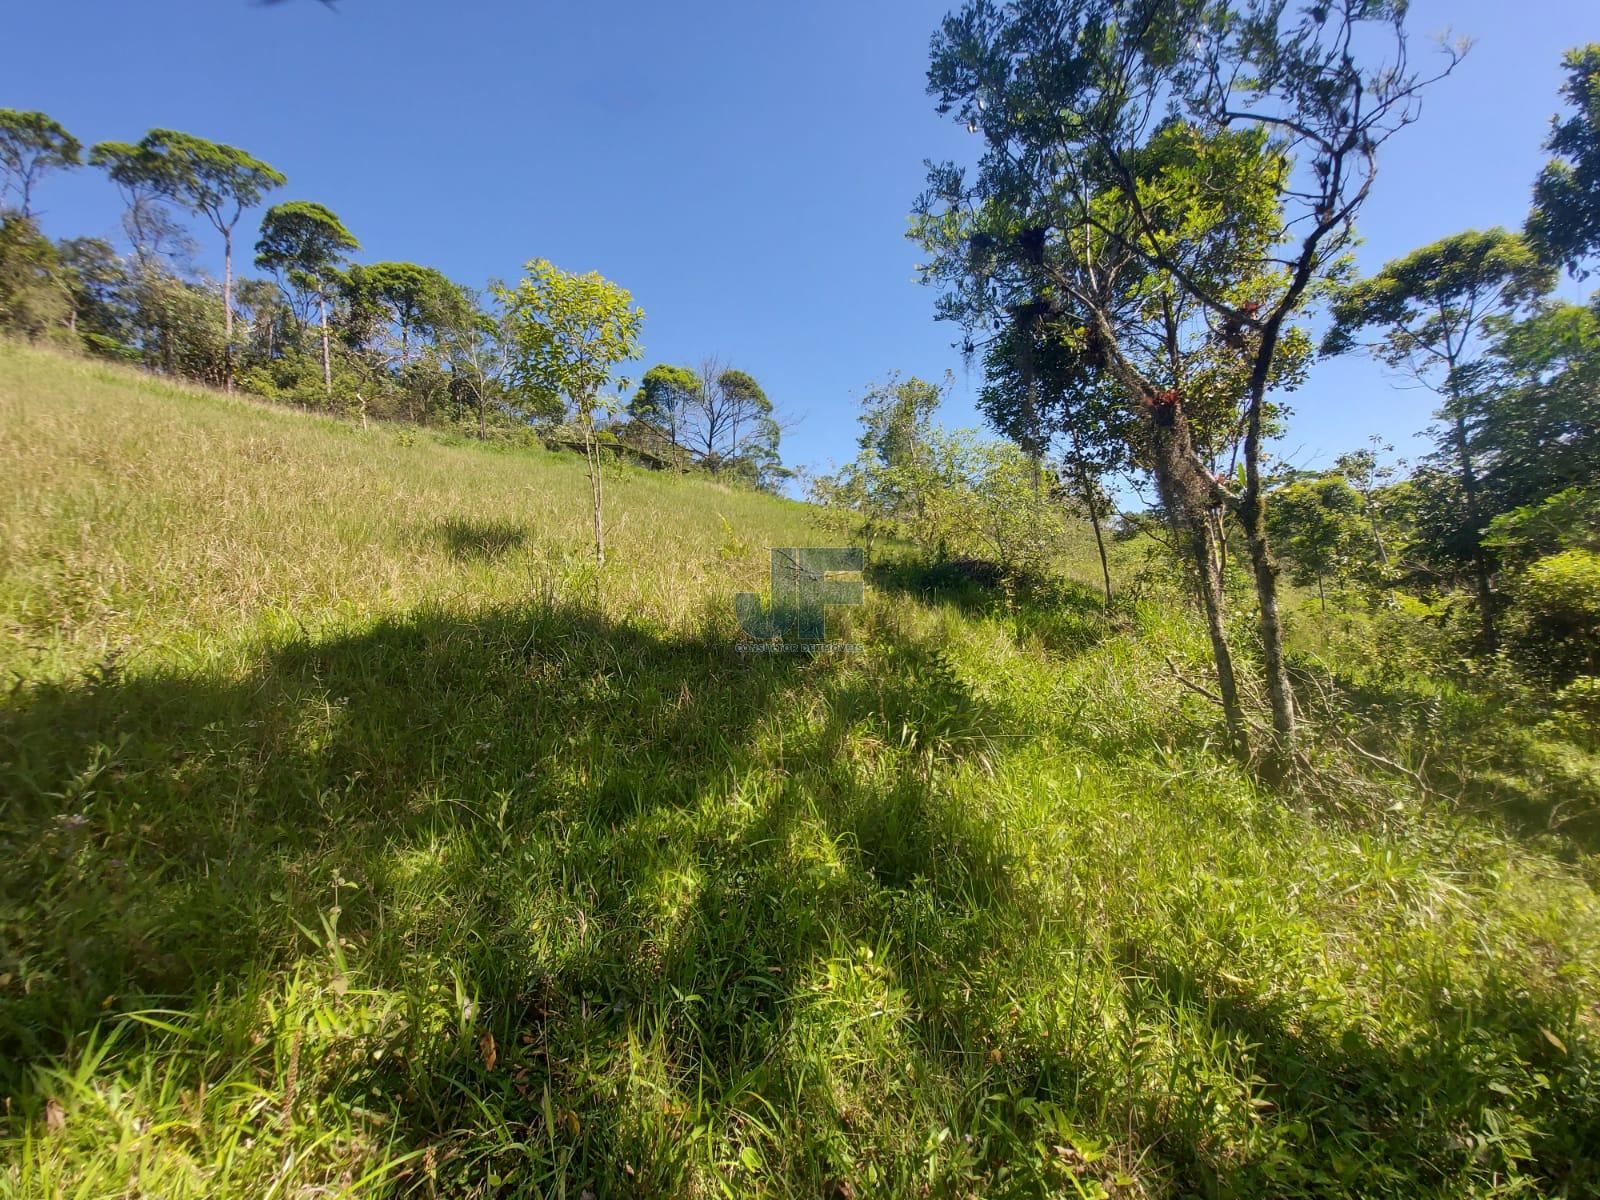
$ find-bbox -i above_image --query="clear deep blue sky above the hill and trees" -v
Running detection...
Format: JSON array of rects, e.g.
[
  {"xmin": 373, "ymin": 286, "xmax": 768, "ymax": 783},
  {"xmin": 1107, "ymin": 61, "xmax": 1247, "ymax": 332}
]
[{"xmin": 0, "ymin": 0, "xmax": 1600, "ymax": 489}]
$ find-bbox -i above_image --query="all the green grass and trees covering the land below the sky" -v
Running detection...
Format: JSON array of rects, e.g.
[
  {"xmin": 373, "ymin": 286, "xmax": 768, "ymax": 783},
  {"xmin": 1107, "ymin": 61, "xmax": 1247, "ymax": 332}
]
[{"xmin": 0, "ymin": 0, "xmax": 1600, "ymax": 1200}]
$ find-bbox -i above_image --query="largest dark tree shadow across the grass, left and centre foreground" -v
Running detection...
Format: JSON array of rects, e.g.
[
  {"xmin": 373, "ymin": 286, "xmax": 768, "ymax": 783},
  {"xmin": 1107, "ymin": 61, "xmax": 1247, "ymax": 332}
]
[{"xmin": 0, "ymin": 604, "xmax": 1011, "ymax": 1194}]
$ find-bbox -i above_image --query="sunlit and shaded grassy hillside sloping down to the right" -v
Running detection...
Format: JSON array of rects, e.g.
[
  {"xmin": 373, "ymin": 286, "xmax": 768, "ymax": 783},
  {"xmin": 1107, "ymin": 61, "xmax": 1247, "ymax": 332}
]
[{"xmin": 0, "ymin": 346, "xmax": 1600, "ymax": 1200}]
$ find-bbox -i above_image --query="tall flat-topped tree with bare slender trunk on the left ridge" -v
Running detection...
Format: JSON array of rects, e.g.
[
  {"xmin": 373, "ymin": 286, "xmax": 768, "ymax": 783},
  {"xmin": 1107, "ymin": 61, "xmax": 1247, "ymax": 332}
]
[{"xmin": 111, "ymin": 130, "xmax": 285, "ymax": 390}]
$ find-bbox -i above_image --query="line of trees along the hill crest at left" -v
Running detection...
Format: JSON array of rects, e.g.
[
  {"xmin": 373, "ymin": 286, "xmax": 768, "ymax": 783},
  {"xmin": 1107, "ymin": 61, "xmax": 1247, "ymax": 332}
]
[{"xmin": 0, "ymin": 109, "xmax": 790, "ymax": 490}]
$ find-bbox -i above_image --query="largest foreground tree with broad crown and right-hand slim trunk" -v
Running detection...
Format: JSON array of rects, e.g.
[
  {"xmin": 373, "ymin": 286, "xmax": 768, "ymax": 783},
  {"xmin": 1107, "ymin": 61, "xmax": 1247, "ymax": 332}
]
[{"xmin": 914, "ymin": 0, "xmax": 1454, "ymax": 774}]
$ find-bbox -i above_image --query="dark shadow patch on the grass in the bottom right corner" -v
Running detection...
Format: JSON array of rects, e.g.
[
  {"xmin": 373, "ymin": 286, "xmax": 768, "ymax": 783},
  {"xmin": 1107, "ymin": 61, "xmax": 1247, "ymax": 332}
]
[{"xmin": 1120, "ymin": 946, "xmax": 1600, "ymax": 1195}]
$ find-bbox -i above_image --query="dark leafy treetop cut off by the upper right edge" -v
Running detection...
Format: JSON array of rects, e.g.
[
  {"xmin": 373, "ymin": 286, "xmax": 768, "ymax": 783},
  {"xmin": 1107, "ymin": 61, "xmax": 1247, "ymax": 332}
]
[{"xmin": 1528, "ymin": 42, "xmax": 1600, "ymax": 275}]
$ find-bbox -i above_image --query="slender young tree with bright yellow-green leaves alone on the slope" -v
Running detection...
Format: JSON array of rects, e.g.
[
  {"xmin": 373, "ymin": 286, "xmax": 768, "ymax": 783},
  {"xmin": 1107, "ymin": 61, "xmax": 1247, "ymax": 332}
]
[{"xmin": 498, "ymin": 258, "xmax": 645, "ymax": 566}]
